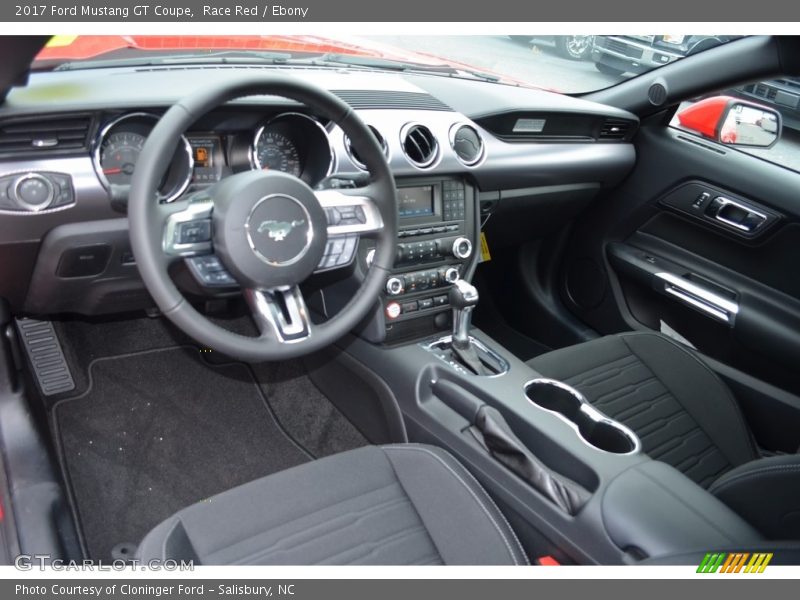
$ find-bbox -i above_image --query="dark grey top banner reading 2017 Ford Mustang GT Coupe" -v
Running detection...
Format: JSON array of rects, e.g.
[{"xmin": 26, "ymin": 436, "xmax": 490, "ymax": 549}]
[{"xmin": 0, "ymin": 0, "xmax": 800, "ymax": 21}]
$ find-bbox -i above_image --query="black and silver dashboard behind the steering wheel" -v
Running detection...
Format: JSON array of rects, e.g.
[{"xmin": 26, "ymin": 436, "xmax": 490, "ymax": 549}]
[{"xmin": 0, "ymin": 65, "xmax": 638, "ymax": 332}]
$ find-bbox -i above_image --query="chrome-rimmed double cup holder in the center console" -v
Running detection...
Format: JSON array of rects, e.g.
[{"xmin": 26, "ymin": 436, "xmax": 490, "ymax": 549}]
[{"xmin": 525, "ymin": 379, "xmax": 641, "ymax": 454}]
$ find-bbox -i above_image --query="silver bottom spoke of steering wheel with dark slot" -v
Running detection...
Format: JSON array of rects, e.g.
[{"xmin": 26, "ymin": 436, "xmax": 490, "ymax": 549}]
[{"xmin": 244, "ymin": 286, "xmax": 312, "ymax": 344}]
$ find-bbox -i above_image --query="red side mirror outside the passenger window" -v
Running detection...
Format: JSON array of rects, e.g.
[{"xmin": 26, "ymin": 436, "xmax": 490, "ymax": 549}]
[{"xmin": 678, "ymin": 96, "xmax": 783, "ymax": 148}]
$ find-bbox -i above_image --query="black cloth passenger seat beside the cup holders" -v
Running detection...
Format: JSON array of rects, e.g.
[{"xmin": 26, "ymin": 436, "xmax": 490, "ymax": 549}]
[{"xmin": 528, "ymin": 332, "xmax": 800, "ymax": 539}]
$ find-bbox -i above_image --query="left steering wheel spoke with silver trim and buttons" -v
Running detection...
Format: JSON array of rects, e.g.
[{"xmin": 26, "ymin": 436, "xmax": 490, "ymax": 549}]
[{"xmin": 161, "ymin": 192, "xmax": 214, "ymax": 258}]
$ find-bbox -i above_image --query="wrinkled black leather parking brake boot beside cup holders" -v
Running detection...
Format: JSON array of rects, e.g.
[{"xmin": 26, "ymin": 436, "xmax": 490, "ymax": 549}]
[{"xmin": 470, "ymin": 405, "xmax": 590, "ymax": 515}]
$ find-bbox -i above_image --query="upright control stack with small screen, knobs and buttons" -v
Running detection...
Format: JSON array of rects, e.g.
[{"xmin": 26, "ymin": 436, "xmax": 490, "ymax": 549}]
[{"xmin": 367, "ymin": 177, "xmax": 478, "ymax": 344}]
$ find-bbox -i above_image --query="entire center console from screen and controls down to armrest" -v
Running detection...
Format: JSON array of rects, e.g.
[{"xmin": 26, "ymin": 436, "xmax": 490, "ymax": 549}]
[{"xmin": 324, "ymin": 178, "xmax": 763, "ymax": 564}]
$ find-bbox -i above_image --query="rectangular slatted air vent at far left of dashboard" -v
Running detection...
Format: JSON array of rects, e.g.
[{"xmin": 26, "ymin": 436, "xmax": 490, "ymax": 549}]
[{"xmin": 0, "ymin": 115, "xmax": 92, "ymax": 154}]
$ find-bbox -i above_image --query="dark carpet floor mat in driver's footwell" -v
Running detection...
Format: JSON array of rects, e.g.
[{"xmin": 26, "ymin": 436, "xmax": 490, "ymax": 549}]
[{"xmin": 53, "ymin": 347, "xmax": 310, "ymax": 560}]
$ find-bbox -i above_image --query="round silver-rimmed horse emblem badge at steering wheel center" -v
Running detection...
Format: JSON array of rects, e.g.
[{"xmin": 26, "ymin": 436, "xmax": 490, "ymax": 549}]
[{"xmin": 245, "ymin": 194, "xmax": 313, "ymax": 267}]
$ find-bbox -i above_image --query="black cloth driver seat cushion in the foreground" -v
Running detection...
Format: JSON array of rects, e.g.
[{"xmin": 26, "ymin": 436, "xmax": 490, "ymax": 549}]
[{"xmin": 137, "ymin": 444, "xmax": 527, "ymax": 565}]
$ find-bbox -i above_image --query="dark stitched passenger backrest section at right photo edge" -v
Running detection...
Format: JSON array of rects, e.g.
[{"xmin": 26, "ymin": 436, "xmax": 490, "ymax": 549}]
[{"xmin": 708, "ymin": 454, "xmax": 800, "ymax": 540}]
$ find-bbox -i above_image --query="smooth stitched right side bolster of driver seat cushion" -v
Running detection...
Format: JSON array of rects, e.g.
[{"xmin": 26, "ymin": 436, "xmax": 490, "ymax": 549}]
[{"xmin": 383, "ymin": 444, "xmax": 528, "ymax": 565}]
